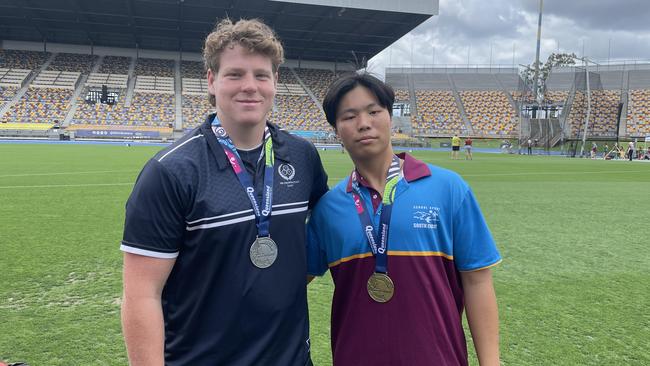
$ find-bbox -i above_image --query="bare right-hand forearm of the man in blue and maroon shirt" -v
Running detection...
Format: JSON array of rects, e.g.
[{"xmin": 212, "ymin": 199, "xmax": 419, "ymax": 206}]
[{"xmin": 460, "ymin": 269, "xmax": 499, "ymax": 366}]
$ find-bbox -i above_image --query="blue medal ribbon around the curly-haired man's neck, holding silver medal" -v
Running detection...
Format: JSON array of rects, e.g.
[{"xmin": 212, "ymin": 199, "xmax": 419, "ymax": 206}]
[{"xmin": 212, "ymin": 116, "xmax": 275, "ymax": 237}]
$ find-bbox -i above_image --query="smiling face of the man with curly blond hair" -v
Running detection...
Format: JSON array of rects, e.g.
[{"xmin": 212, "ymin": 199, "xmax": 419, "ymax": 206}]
[{"xmin": 208, "ymin": 45, "xmax": 277, "ymax": 127}]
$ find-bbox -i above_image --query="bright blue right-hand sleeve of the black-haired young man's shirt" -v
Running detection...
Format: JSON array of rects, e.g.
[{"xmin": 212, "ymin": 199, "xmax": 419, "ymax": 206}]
[{"xmin": 453, "ymin": 187, "xmax": 501, "ymax": 271}]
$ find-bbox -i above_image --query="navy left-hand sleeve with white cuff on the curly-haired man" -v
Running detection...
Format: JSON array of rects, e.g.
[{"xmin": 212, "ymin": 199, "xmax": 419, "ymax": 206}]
[{"xmin": 121, "ymin": 159, "xmax": 186, "ymax": 258}]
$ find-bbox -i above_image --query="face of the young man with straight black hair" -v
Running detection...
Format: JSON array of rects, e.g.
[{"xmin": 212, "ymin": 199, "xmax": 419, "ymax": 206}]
[{"xmin": 336, "ymin": 85, "xmax": 392, "ymax": 159}]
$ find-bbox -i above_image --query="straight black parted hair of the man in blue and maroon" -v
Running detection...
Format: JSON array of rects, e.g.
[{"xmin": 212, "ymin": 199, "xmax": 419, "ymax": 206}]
[{"xmin": 323, "ymin": 72, "xmax": 395, "ymax": 128}]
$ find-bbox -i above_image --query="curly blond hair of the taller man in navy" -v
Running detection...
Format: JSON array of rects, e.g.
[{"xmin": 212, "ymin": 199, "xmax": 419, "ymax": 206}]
[{"xmin": 203, "ymin": 18, "xmax": 284, "ymax": 106}]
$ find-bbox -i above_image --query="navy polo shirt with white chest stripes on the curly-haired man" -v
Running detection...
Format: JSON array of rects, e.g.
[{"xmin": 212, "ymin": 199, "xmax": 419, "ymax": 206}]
[{"xmin": 121, "ymin": 115, "xmax": 327, "ymax": 365}]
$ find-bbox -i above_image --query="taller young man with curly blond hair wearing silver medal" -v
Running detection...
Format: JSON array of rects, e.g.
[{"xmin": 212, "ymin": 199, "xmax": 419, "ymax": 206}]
[{"xmin": 121, "ymin": 20, "xmax": 327, "ymax": 366}]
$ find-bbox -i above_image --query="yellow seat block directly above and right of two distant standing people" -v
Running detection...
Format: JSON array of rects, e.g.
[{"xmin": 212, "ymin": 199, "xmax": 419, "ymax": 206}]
[{"xmin": 460, "ymin": 90, "xmax": 517, "ymax": 136}]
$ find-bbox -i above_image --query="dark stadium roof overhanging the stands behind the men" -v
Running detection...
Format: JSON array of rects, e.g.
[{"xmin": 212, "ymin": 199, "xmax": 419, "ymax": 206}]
[{"xmin": 0, "ymin": 0, "xmax": 437, "ymax": 62}]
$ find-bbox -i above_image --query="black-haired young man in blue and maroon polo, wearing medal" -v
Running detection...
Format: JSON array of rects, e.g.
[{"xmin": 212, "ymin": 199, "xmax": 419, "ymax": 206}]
[{"xmin": 307, "ymin": 74, "xmax": 501, "ymax": 366}]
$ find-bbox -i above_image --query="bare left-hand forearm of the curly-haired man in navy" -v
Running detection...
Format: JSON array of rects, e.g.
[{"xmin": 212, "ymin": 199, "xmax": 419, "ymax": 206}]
[{"xmin": 122, "ymin": 253, "xmax": 175, "ymax": 366}]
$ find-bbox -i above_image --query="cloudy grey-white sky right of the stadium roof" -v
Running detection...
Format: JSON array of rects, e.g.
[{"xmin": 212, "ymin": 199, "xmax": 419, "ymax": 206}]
[{"xmin": 369, "ymin": 0, "xmax": 650, "ymax": 74}]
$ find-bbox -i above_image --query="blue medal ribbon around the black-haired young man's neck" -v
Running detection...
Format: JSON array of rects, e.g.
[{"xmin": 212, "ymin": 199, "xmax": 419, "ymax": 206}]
[{"xmin": 350, "ymin": 155, "xmax": 400, "ymax": 273}]
